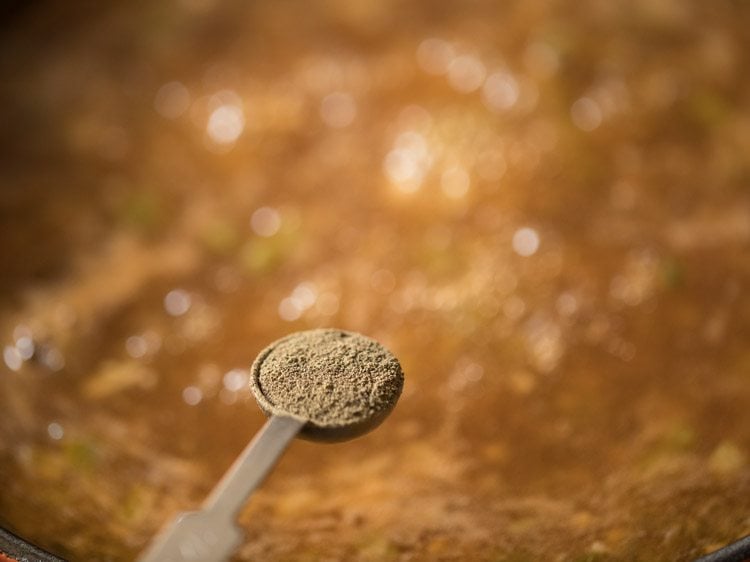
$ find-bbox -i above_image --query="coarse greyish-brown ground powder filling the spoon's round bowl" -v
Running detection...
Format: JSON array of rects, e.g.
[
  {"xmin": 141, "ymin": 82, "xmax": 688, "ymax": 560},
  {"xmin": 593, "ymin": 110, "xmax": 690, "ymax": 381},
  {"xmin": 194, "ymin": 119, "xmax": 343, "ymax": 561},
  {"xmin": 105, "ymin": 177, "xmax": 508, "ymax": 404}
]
[{"xmin": 252, "ymin": 329, "xmax": 404, "ymax": 428}]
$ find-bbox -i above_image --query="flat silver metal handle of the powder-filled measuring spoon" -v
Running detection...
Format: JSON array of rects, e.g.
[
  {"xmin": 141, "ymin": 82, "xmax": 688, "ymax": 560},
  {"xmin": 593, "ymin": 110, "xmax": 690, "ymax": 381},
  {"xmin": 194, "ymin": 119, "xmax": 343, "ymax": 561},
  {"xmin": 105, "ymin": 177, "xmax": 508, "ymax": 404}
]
[{"xmin": 139, "ymin": 416, "xmax": 306, "ymax": 562}]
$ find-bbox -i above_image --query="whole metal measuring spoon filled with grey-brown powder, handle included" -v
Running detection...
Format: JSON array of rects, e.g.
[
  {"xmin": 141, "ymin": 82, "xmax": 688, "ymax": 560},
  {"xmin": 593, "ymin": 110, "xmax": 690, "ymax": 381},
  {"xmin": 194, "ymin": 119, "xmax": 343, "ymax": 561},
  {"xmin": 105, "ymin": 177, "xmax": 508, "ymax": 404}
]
[{"xmin": 139, "ymin": 330, "xmax": 404, "ymax": 562}]
